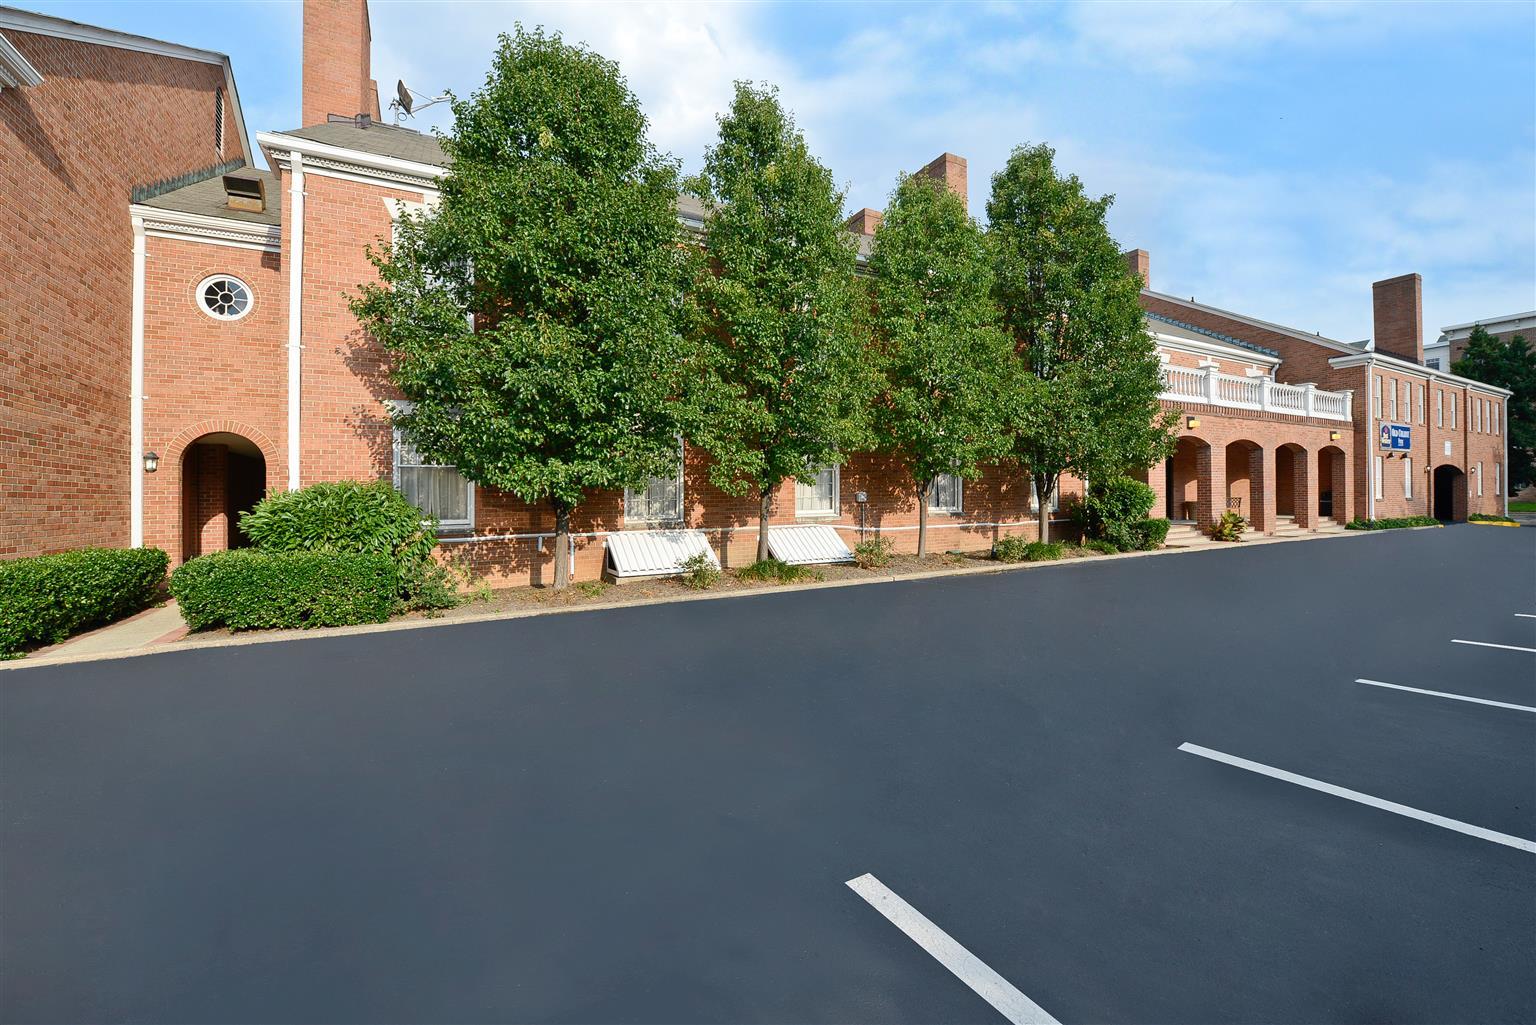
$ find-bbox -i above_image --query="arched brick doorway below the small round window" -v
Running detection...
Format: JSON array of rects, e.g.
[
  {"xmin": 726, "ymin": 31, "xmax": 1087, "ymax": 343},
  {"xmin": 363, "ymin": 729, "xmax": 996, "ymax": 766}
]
[{"xmin": 181, "ymin": 432, "xmax": 267, "ymax": 561}]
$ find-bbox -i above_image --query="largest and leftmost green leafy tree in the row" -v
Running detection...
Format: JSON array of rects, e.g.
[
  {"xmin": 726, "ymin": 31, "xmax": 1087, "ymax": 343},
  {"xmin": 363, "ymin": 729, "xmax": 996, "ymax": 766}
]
[{"xmin": 352, "ymin": 26, "xmax": 696, "ymax": 589}]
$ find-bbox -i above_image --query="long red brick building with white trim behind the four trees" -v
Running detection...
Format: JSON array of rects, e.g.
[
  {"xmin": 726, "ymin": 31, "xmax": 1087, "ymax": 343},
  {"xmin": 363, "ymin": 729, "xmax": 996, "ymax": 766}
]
[{"xmin": 0, "ymin": 0, "xmax": 1502, "ymax": 582}]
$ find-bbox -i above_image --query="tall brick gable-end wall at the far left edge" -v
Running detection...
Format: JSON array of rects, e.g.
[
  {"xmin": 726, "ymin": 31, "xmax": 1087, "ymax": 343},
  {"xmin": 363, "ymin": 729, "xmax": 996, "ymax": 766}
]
[{"xmin": 0, "ymin": 31, "xmax": 241, "ymax": 556}]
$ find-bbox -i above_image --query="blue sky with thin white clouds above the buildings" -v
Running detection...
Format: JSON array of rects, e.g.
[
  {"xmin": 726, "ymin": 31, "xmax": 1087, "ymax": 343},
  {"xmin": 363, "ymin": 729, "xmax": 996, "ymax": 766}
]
[{"xmin": 33, "ymin": 0, "xmax": 1536, "ymax": 340}]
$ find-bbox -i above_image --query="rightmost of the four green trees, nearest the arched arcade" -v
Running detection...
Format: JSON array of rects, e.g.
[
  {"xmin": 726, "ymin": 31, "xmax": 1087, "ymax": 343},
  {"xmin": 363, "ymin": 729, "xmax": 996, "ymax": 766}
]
[{"xmin": 986, "ymin": 144, "xmax": 1177, "ymax": 539}]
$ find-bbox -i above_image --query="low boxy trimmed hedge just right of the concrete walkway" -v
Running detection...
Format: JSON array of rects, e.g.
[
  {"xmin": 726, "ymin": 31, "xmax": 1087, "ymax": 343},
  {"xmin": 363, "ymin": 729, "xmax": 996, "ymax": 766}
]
[{"xmin": 170, "ymin": 549, "xmax": 399, "ymax": 630}]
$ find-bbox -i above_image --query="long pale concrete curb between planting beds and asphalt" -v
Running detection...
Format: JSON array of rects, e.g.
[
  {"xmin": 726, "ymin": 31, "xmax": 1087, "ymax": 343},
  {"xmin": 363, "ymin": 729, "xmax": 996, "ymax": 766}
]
[{"xmin": 0, "ymin": 527, "xmax": 1382, "ymax": 675}]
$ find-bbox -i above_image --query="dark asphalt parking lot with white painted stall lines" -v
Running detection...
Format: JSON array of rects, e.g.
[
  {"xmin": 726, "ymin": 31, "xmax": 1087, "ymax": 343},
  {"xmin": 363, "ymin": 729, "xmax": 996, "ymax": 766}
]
[{"xmin": 0, "ymin": 527, "xmax": 1536, "ymax": 1023}]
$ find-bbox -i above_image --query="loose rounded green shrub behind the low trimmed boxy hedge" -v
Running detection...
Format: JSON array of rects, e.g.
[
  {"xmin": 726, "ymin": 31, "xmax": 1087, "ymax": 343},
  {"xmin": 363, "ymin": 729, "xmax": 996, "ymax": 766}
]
[{"xmin": 240, "ymin": 481, "xmax": 459, "ymax": 609}]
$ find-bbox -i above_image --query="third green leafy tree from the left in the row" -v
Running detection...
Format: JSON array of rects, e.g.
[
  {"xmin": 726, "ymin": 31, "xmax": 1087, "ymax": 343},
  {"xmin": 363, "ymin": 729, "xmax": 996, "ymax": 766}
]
[{"xmin": 869, "ymin": 175, "xmax": 1014, "ymax": 556}]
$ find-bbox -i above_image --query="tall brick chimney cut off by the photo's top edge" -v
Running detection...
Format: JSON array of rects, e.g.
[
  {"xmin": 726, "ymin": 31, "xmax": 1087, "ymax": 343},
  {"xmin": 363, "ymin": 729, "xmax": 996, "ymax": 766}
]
[{"xmin": 303, "ymin": 0, "xmax": 379, "ymax": 126}]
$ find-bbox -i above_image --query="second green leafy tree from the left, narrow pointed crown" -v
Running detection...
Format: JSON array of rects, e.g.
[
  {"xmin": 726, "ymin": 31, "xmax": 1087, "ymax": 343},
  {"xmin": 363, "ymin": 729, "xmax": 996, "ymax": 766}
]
[{"xmin": 690, "ymin": 83, "xmax": 872, "ymax": 561}]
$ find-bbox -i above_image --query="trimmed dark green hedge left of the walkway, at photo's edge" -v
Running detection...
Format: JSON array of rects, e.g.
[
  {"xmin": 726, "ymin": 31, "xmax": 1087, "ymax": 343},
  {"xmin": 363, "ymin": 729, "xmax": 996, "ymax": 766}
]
[{"xmin": 0, "ymin": 549, "xmax": 167, "ymax": 658}]
